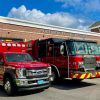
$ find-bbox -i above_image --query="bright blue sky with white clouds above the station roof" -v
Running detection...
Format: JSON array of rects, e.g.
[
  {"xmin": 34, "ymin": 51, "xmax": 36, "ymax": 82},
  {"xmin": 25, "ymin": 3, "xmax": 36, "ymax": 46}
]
[{"xmin": 0, "ymin": 0, "xmax": 100, "ymax": 30}]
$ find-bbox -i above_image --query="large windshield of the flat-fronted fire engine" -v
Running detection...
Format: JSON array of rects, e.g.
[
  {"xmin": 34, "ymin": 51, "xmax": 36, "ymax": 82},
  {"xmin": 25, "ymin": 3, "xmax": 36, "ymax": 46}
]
[{"xmin": 72, "ymin": 41, "xmax": 99, "ymax": 55}]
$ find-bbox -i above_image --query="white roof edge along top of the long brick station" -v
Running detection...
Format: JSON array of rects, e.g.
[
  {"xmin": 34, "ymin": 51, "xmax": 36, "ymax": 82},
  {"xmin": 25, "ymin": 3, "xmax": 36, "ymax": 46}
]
[{"xmin": 0, "ymin": 16, "xmax": 100, "ymax": 35}]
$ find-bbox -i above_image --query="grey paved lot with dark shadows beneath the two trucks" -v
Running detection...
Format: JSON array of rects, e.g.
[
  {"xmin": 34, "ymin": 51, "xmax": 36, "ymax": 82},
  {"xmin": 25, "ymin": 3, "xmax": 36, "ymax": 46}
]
[{"xmin": 0, "ymin": 79, "xmax": 100, "ymax": 100}]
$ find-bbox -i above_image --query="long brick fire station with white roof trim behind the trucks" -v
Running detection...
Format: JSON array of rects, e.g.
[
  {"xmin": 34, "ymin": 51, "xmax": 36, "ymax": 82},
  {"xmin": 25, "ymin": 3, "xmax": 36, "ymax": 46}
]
[{"xmin": 0, "ymin": 17, "xmax": 100, "ymax": 43}]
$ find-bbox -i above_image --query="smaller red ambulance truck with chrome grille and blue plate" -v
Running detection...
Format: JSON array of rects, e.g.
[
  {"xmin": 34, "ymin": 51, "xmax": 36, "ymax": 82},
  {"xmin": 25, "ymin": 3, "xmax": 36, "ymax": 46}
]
[{"xmin": 0, "ymin": 42, "xmax": 51, "ymax": 95}]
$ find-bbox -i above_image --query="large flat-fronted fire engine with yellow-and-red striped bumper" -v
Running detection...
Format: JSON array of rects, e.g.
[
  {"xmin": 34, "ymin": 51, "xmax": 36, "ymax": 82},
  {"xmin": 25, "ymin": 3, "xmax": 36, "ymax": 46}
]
[{"xmin": 27, "ymin": 38, "xmax": 100, "ymax": 81}]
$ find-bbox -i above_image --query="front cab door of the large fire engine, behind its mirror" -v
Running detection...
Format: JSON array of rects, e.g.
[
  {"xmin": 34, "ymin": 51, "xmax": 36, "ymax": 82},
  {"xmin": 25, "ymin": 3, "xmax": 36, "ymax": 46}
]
[{"xmin": 54, "ymin": 42, "xmax": 69, "ymax": 78}]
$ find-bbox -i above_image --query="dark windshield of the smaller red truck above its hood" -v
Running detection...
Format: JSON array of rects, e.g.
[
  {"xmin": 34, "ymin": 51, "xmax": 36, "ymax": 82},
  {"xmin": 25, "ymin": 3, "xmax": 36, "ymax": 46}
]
[{"xmin": 5, "ymin": 53, "xmax": 33, "ymax": 62}]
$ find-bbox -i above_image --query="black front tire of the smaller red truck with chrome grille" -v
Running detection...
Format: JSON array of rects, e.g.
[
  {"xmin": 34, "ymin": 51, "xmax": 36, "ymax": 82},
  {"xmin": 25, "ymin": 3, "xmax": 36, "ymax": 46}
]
[{"xmin": 4, "ymin": 77, "xmax": 16, "ymax": 96}]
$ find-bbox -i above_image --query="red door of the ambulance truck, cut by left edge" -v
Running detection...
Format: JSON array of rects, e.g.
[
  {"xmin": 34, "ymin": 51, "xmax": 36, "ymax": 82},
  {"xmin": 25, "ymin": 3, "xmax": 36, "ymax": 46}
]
[{"xmin": 0, "ymin": 54, "xmax": 4, "ymax": 85}]
